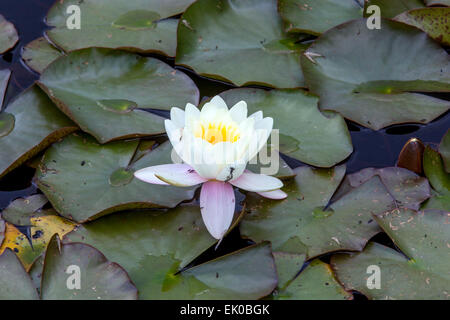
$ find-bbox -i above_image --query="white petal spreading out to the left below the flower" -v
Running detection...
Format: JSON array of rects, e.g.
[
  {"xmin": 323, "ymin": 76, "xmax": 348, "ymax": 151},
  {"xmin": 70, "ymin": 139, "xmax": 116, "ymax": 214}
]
[{"xmin": 134, "ymin": 164, "xmax": 207, "ymax": 187}]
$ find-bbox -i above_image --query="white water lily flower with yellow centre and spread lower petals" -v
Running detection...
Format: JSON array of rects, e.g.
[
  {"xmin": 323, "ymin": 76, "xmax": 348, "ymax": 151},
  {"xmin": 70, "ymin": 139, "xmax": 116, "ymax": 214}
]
[{"xmin": 134, "ymin": 96, "xmax": 287, "ymax": 239}]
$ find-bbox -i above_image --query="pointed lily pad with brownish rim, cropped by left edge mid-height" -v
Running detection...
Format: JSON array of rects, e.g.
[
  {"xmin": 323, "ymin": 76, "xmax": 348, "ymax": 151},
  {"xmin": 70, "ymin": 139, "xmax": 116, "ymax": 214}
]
[{"xmin": 0, "ymin": 86, "xmax": 78, "ymax": 177}]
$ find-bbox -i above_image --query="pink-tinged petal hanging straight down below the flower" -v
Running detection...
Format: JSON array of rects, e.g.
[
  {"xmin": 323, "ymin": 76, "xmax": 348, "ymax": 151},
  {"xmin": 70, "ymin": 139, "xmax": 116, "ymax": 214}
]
[{"xmin": 200, "ymin": 181, "xmax": 235, "ymax": 239}]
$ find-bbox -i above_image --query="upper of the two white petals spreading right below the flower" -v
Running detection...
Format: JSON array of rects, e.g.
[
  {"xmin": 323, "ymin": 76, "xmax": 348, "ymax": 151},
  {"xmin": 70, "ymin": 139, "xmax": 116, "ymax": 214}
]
[{"xmin": 230, "ymin": 170, "xmax": 283, "ymax": 192}]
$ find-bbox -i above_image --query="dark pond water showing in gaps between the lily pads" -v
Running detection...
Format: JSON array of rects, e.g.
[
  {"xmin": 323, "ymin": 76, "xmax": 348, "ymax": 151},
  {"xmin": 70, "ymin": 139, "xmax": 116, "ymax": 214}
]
[{"xmin": 0, "ymin": 0, "xmax": 450, "ymax": 300}]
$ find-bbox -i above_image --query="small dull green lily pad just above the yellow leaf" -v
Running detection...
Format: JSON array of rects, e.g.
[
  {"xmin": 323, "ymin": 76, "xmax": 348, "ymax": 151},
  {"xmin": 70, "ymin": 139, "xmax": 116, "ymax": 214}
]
[{"xmin": 0, "ymin": 194, "xmax": 48, "ymax": 225}]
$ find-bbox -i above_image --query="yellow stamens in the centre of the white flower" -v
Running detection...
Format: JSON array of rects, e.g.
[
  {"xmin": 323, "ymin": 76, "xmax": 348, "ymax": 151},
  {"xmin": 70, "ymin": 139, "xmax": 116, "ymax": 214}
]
[{"xmin": 195, "ymin": 122, "xmax": 240, "ymax": 144}]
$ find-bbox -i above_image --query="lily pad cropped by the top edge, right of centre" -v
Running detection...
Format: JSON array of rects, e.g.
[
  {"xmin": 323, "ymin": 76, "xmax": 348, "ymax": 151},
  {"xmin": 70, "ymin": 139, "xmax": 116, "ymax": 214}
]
[{"xmin": 278, "ymin": 0, "xmax": 363, "ymax": 35}]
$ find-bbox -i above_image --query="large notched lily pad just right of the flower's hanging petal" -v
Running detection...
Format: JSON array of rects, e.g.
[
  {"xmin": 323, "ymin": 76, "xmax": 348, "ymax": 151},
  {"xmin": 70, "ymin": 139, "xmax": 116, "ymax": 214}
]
[{"xmin": 240, "ymin": 166, "xmax": 395, "ymax": 257}]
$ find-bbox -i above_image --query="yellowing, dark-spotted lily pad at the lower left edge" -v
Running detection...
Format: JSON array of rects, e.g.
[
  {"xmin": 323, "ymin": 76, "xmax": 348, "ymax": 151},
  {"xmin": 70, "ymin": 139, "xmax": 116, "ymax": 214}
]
[{"xmin": 0, "ymin": 209, "xmax": 75, "ymax": 270}]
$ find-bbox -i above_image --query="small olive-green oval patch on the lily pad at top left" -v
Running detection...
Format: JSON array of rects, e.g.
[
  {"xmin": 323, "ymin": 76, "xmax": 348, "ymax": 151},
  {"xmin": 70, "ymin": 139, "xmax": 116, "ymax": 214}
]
[{"xmin": 112, "ymin": 10, "xmax": 161, "ymax": 30}]
